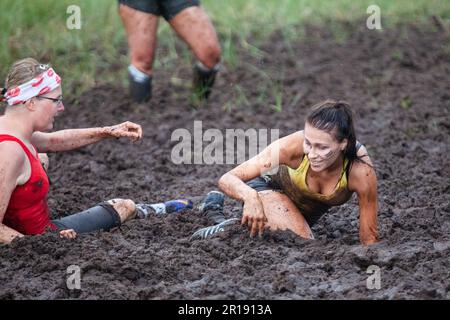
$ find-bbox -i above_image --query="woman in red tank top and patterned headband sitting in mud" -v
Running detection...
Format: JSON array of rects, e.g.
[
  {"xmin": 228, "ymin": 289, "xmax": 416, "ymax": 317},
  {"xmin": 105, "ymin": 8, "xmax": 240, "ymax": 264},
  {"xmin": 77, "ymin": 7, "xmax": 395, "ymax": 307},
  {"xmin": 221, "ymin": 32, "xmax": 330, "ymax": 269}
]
[{"xmin": 0, "ymin": 58, "xmax": 191, "ymax": 243}]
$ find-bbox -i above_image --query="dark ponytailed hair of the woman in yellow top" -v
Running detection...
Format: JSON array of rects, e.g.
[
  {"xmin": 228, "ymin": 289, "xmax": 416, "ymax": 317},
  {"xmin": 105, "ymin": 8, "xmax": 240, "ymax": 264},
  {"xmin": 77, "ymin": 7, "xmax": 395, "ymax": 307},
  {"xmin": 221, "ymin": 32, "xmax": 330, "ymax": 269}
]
[{"xmin": 306, "ymin": 99, "xmax": 359, "ymax": 164}]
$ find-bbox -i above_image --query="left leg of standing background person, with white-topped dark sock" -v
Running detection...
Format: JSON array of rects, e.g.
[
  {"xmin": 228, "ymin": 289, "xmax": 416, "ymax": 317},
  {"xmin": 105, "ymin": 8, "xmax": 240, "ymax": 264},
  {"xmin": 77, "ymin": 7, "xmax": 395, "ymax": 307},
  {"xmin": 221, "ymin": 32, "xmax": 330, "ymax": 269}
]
[{"xmin": 119, "ymin": 4, "xmax": 159, "ymax": 102}]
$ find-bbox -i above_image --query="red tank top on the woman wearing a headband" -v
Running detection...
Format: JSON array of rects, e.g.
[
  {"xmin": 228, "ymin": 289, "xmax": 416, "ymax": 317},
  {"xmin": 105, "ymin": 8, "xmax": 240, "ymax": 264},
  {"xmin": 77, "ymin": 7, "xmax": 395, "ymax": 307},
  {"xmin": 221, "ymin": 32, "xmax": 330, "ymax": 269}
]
[{"xmin": 0, "ymin": 134, "xmax": 56, "ymax": 235}]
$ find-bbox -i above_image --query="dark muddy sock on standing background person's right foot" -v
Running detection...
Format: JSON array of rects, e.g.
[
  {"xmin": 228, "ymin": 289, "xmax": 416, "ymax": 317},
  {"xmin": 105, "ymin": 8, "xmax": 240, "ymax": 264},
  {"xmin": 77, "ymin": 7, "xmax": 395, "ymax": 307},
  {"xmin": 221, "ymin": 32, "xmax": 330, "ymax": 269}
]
[{"xmin": 192, "ymin": 61, "xmax": 220, "ymax": 101}]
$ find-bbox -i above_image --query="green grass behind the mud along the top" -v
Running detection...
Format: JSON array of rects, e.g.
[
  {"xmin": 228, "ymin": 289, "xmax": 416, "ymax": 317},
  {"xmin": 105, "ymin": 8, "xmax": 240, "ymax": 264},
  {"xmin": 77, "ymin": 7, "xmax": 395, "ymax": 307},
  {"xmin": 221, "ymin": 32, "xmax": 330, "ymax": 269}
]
[{"xmin": 0, "ymin": 0, "xmax": 450, "ymax": 97}]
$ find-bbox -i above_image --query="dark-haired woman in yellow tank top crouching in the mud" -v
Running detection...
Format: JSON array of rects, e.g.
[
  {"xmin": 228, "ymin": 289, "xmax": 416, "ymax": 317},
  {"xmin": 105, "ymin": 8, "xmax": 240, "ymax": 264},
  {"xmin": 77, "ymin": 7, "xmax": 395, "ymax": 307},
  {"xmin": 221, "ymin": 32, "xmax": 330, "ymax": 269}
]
[{"xmin": 219, "ymin": 100, "xmax": 378, "ymax": 245}]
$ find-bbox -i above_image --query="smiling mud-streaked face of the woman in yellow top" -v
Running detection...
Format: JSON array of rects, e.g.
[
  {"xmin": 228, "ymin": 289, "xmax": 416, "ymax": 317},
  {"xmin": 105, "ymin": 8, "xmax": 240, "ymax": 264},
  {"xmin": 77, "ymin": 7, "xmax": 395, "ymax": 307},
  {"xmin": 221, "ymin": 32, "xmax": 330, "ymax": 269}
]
[{"xmin": 303, "ymin": 123, "xmax": 347, "ymax": 172}]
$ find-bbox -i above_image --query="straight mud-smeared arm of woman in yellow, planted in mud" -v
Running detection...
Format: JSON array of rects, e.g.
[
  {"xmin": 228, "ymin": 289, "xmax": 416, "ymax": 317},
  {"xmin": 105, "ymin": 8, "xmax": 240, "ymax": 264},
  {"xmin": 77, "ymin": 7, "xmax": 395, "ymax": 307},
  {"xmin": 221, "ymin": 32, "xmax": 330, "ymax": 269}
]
[{"xmin": 349, "ymin": 162, "xmax": 378, "ymax": 245}]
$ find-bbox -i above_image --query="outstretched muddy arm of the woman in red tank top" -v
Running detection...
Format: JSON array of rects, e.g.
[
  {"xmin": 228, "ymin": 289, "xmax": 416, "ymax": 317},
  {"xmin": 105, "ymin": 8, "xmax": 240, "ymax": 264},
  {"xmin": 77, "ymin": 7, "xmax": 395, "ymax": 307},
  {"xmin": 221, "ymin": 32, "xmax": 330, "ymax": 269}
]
[{"xmin": 31, "ymin": 121, "xmax": 142, "ymax": 152}]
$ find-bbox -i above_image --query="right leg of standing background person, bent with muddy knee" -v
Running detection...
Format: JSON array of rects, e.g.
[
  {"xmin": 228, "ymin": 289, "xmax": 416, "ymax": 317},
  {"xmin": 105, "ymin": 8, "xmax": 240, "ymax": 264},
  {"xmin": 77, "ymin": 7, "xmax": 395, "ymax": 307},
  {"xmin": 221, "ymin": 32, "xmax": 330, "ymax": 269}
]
[{"xmin": 169, "ymin": 6, "xmax": 221, "ymax": 100}]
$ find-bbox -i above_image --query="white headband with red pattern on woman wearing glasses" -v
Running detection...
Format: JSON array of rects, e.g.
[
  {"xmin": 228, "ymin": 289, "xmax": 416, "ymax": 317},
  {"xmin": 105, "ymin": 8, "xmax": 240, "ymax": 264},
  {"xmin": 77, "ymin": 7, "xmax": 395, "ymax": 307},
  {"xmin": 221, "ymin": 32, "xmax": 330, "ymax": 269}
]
[{"xmin": 5, "ymin": 68, "xmax": 61, "ymax": 106}]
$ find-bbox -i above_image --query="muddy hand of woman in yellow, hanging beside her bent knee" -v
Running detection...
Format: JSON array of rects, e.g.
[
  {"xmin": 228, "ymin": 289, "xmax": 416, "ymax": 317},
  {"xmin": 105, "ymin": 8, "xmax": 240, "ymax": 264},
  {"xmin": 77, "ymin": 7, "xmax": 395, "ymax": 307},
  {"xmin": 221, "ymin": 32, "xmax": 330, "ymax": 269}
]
[{"xmin": 241, "ymin": 195, "xmax": 267, "ymax": 237}]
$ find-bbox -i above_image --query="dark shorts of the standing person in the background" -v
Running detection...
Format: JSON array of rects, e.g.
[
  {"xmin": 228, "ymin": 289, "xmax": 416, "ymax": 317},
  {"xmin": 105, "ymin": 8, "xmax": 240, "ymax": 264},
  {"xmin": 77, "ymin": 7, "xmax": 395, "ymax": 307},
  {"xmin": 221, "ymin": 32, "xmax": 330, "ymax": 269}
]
[{"xmin": 119, "ymin": 0, "xmax": 200, "ymax": 21}]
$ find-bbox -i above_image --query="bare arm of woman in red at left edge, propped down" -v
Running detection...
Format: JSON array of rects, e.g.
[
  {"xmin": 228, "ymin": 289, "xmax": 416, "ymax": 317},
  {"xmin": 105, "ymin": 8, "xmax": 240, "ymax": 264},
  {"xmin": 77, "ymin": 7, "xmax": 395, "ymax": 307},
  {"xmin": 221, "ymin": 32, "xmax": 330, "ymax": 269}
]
[{"xmin": 0, "ymin": 142, "xmax": 25, "ymax": 243}]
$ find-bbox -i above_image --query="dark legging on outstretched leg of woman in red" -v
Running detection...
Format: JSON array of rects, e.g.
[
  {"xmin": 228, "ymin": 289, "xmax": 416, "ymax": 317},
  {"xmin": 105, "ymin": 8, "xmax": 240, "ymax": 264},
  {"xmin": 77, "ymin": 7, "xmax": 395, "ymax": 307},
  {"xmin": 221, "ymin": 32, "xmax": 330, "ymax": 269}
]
[{"xmin": 52, "ymin": 202, "xmax": 121, "ymax": 233}]
